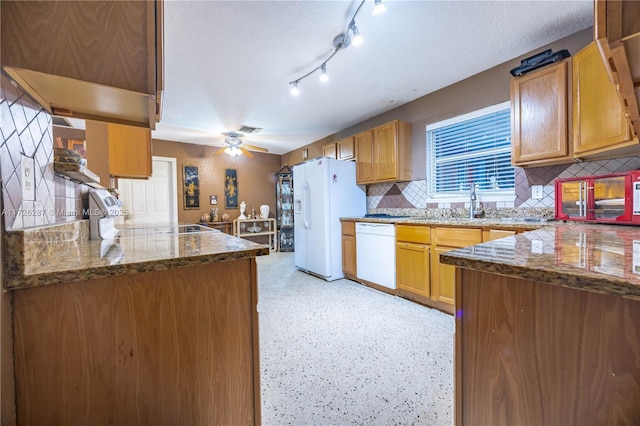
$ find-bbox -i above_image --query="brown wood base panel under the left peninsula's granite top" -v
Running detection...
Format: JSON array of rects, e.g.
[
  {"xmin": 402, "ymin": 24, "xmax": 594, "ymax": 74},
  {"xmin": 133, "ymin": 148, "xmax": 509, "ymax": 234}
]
[{"xmin": 12, "ymin": 258, "xmax": 260, "ymax": 425}]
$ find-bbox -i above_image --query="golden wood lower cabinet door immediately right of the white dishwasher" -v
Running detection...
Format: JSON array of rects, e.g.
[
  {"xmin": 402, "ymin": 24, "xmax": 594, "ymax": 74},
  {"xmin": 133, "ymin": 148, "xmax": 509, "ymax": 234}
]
[{"xmin": 396, "ymin": 242, "xmax": 431, "ymax": 297}]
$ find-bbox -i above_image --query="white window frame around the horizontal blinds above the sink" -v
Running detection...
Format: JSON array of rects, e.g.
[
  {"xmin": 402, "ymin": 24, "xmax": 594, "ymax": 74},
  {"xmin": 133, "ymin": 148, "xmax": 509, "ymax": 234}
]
[{"xmin": 425, "ymin": 101, "xmax": 516, "ymax": 203}]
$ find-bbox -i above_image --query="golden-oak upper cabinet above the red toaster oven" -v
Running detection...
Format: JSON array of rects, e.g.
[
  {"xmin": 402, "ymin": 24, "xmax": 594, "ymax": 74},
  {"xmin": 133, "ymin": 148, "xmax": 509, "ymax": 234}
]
[{"xmin": 573, "ymin": 42, "xmax": 640, "ymax": 159}]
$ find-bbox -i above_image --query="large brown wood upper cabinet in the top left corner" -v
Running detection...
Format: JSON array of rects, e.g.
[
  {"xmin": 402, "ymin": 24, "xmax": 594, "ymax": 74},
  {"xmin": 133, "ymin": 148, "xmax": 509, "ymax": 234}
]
[{"xmin": 0, "ymin": 1, "xmax": 163, "ymax": 128}]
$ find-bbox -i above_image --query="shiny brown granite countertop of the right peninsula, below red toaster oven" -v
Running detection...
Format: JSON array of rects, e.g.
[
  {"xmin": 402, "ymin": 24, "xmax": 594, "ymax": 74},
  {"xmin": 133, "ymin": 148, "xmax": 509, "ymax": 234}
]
[{"xmin": 440, "ymin": 222, "xmax": 640, "ymax": 300}]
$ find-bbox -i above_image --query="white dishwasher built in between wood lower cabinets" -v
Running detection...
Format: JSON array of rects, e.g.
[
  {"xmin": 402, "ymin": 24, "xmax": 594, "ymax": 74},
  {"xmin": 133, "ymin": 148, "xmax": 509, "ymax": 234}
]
[{"xmin": 356, "ymin": 222, "xmax": 396, "ymax": 289}]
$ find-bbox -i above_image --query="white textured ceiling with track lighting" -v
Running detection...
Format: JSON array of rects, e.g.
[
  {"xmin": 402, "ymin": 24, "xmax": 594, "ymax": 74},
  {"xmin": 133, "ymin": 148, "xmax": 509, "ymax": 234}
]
[{"xmin": 153, "ymin": 0, "xmax": 593, "ymax": 154}]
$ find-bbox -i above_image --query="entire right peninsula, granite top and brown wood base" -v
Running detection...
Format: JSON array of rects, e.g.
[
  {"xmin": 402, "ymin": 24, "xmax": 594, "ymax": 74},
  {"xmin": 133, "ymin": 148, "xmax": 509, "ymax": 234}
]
[{"xmin": 441, "ymin": 223, "xmax": 640, "ymax": 425}]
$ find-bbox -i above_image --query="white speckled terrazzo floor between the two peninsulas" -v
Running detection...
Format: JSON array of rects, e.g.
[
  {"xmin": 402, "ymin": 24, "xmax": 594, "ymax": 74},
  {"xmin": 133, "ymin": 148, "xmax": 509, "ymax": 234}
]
[{"xmin": 257, "ymin": 253, "xmax": 454, "ymax": 426}]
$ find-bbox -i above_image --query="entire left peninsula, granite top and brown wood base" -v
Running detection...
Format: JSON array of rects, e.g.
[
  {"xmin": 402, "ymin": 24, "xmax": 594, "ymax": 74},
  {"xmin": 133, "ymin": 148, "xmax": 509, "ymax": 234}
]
[{"xmin": 4, "ymin": 221, "xmax": 269, "ymax": 425}]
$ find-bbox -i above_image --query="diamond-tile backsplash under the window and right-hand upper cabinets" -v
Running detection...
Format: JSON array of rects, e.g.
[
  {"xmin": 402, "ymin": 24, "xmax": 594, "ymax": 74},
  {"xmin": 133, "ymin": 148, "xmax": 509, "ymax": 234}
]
[{"xmin": 367, "ymin": 156, "xmax": 640, "ymax": 215}]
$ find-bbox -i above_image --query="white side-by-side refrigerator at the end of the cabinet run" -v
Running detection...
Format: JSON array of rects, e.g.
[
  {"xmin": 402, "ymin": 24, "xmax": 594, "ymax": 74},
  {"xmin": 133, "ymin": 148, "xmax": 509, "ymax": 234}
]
[{"xmin": 293, "ymin": 158, "xmax": 367, "ymax": 281}]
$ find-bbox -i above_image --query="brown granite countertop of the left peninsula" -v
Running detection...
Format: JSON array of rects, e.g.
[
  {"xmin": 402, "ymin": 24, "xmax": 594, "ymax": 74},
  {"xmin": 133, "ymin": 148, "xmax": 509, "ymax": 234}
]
[{"xmin": 3, "ymin": 221, "xmax": 269, "ymax": 289}]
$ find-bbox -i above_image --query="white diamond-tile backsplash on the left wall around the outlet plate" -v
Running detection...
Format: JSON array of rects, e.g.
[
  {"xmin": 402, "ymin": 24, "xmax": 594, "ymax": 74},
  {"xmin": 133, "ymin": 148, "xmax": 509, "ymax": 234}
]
[{"xmin": 0, "ymin": 75, "xmax": 87, "ymax": 230}]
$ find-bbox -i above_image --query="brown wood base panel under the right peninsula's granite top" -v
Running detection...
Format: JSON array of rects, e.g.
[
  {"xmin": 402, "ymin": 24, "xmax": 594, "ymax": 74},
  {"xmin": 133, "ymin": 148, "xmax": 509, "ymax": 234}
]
[{"xmin": 455, "ymin": 268, "xmax": 640, "ymax": 426}]
